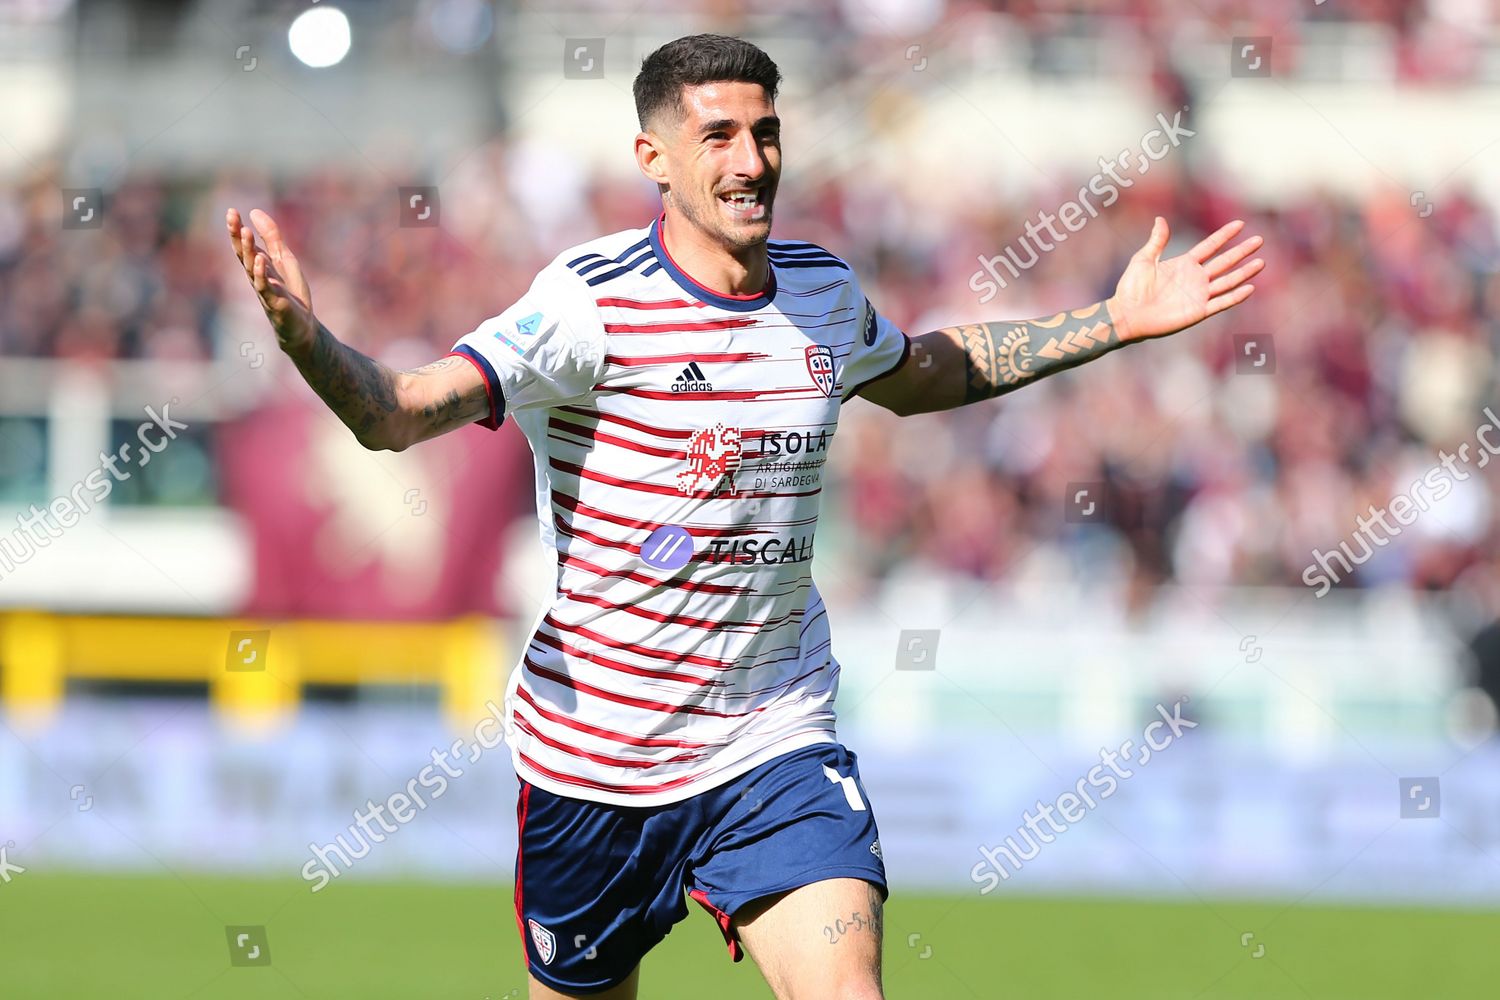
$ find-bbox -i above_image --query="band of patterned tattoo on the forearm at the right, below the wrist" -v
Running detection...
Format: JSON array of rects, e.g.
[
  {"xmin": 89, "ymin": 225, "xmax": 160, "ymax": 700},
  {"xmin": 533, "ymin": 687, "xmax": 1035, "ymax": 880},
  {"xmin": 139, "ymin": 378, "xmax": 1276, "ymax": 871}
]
[{"xmin": 950, "ymin": 303, "xmax": 1124, "ymax": 403}]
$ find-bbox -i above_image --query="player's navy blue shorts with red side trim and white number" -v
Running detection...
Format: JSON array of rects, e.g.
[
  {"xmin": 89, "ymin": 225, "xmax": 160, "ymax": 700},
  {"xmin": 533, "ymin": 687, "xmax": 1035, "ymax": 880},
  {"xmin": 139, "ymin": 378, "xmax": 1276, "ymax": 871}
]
[{"xmin": 516, "ymin": 744, "xmax": 887, "ymax": 994}]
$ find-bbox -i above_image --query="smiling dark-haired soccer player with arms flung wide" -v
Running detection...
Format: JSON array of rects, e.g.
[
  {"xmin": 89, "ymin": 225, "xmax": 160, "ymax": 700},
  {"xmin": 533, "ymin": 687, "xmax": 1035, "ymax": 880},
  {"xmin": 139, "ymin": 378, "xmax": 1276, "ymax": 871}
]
[{"xmin": 227, "ymin": 34, "xmax": 1263, "ymax": 1000}]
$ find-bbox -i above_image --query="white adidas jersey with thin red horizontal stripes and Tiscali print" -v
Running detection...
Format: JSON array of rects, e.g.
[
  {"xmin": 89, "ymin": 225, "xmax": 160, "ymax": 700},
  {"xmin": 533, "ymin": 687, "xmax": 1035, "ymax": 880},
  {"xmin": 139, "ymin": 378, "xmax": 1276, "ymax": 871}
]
[{"xmin": 453, "ymin": 217, "xmax": 909, "ymax": 805}]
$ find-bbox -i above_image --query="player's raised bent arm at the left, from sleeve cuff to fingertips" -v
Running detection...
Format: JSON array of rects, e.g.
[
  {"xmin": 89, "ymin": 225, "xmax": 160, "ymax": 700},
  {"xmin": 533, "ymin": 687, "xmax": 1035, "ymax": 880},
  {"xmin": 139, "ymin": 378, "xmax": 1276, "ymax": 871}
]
[{"xmin": 225, "ymin": 208, "xmax": 489, "ymax": 451}]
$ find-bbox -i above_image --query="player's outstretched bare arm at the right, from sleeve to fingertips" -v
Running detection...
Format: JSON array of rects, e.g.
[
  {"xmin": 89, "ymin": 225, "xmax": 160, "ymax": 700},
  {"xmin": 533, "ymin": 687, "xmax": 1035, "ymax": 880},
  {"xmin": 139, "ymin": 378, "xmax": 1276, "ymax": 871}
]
[{"xmin": 860, "ymin": 217, "xmax": 1266, "ymax": 417}]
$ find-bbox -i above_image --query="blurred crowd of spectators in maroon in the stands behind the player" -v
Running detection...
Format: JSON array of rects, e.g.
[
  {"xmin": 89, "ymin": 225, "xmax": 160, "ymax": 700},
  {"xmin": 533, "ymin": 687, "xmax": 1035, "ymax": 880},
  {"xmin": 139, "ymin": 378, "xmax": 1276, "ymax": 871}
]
[{"xmin": 0, "ymin": 0, "xmax": 1500, "ymax": 615}]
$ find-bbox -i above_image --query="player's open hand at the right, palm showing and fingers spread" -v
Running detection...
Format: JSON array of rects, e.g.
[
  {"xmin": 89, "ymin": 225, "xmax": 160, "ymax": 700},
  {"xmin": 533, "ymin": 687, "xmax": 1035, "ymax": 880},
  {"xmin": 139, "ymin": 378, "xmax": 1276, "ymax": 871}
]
[{"xmin": 1107, "ymin": 216, "xmax": 1266, "ymax": 340}]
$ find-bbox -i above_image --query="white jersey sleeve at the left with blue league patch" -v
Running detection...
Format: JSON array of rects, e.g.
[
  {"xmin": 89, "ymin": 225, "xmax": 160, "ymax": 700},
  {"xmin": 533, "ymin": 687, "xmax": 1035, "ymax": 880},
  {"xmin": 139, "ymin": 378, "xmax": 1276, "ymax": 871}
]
[{"xmin": 453, "ymin": 264, "xmax": 605, "ymax": 430}]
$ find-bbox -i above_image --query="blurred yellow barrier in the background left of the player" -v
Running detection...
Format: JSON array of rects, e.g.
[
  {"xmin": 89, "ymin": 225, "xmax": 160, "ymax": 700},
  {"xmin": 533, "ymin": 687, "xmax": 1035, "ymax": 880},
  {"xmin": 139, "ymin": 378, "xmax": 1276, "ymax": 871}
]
[{"xmin": 0, "ymin": 612, "xmax": 504, "ymax": 727}]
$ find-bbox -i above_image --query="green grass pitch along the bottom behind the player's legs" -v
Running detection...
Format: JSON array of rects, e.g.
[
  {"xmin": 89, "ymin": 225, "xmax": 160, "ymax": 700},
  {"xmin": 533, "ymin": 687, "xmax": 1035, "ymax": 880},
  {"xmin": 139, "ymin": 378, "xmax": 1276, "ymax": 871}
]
[{"xmin": 0, "ymin": 871, "xmax": 1500, "ymax": 1000}]
